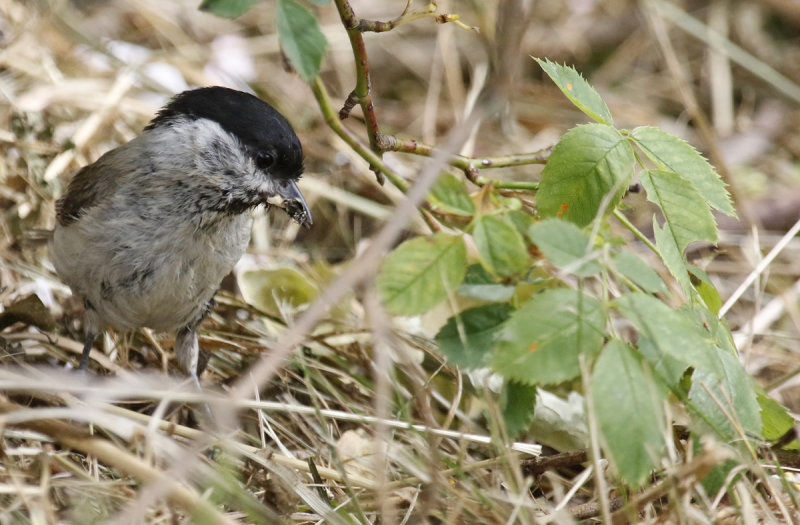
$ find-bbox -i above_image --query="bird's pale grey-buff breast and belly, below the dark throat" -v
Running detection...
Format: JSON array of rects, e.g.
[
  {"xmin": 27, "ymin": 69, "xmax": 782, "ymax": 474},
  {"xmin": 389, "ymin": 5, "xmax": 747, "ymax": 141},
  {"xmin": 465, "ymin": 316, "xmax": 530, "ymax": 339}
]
[{"xmin": 54, "ymin": 193, "xmax": 252, "ymax": 331}]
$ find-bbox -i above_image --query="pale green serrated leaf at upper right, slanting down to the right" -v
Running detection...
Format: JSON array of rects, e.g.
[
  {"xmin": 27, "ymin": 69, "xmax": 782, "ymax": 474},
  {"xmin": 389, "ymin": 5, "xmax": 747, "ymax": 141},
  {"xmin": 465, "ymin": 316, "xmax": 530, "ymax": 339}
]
[{"xmin": 631, "ymin": 126, "xmax": 736, "ymax": 217}]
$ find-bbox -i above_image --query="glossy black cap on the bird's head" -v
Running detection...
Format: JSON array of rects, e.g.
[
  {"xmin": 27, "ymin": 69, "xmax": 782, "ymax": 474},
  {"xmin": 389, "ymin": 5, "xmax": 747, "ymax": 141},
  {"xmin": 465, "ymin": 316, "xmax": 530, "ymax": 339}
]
[{"xmin": 144, "ymin": 86, "xmax": 303, "ymax": 179}]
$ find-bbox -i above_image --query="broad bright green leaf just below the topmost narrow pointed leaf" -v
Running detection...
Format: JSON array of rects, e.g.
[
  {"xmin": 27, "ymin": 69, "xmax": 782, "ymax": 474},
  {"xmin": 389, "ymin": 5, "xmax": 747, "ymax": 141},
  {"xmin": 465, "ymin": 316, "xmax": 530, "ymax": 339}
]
[{"xmin": 536, "ymin": 124, "xmax": 634, "ymax": 226}]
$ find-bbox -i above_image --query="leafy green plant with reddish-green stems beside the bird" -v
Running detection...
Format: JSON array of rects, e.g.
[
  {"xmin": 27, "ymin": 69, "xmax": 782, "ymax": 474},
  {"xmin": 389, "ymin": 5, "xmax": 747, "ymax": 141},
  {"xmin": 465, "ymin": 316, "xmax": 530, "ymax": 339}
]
[{"xmin": 202, "ymin": 0, "xmax": 792, "ymax": 487}]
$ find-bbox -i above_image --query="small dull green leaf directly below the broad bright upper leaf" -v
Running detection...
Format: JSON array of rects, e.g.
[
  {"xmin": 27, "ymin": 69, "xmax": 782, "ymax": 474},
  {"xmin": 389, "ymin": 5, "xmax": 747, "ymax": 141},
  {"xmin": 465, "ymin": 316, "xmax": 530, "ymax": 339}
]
[{"xmin": 528, "ymin": 219, "xmax": 602, "ymax": 277}]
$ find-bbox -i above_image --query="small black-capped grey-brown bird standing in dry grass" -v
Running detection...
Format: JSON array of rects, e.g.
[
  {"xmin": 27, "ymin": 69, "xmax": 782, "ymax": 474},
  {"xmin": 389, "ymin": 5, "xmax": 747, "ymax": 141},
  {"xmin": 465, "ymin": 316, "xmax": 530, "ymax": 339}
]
[{"xmin": 52, "ymin": 87, "xmax": 312, "ymax": 385}]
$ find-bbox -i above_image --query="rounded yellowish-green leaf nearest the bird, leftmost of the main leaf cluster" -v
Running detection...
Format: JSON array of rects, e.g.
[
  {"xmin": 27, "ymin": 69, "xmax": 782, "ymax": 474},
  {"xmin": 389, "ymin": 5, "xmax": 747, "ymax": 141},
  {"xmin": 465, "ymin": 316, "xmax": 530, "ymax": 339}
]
[{"xmin": 376, "ymin": 233, "xmax": 467, "ymax": 315}]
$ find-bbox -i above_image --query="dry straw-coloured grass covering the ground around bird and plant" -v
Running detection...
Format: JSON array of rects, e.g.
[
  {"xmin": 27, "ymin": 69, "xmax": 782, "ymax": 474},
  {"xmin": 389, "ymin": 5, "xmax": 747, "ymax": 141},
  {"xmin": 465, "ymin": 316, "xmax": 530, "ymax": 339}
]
[{"xmin": 0, "ymin": 0, "xmax": 800, "ymax": 524}]
